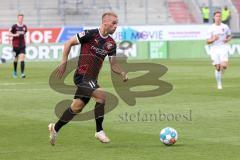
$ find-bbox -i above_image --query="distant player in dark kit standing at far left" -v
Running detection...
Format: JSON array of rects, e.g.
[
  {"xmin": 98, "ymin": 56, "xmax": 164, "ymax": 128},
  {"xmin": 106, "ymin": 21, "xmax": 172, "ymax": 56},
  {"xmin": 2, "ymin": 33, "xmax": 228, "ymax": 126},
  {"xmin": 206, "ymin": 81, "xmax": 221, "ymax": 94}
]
[{"xmin": 9, "ymin": 14, "xmax": 27, "ymax": 78}]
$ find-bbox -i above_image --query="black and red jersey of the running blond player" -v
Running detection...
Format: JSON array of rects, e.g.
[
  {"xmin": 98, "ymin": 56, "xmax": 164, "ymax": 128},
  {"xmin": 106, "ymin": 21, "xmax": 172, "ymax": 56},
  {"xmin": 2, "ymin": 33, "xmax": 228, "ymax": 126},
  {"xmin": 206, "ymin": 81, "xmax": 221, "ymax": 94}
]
[{"xmin": 76, "ymin": 29, "xmax": 116, "ymax": 79}]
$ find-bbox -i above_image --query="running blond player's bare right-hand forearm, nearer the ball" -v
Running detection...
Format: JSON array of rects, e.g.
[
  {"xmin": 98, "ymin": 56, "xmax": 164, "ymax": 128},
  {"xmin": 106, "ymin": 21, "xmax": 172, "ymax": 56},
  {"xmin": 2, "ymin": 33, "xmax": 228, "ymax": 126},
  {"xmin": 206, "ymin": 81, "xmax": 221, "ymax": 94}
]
[{"xmin": 109, "ymin": 56, "xmax": 128, "ymax": 82}]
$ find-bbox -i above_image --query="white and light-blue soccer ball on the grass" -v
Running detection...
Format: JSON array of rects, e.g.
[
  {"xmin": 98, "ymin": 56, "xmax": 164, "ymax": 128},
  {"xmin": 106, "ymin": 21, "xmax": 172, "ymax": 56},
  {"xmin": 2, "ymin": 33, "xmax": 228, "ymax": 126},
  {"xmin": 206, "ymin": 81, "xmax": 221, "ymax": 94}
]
[{"xmin": 160, "ymin": 127, "xmax": 178, "ymax": 146}]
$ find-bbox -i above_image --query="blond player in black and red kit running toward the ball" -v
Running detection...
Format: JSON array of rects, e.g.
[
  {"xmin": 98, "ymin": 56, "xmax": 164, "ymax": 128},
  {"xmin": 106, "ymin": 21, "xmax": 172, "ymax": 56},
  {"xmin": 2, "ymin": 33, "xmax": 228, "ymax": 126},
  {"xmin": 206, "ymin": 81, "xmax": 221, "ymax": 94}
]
[{"xmin": 48, "ymin": 12, "xmax": 128, "ymax": 145}]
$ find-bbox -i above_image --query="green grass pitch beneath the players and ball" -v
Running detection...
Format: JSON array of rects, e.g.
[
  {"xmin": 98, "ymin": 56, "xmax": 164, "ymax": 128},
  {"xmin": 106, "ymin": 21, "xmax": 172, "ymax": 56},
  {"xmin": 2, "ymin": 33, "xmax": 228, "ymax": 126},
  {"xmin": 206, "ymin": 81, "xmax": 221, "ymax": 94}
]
[{"xmin": 0, "ymin": 59, "xmax": 240, "ymax": 160}]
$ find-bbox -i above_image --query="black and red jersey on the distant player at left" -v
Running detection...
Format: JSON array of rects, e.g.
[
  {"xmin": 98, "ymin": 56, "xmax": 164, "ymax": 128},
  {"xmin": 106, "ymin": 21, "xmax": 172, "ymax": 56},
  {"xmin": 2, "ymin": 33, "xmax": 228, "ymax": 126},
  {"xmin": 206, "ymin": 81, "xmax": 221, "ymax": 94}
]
[{"xmin": 10, "ymin": 24, "xmax": 27, "ymax": 48}]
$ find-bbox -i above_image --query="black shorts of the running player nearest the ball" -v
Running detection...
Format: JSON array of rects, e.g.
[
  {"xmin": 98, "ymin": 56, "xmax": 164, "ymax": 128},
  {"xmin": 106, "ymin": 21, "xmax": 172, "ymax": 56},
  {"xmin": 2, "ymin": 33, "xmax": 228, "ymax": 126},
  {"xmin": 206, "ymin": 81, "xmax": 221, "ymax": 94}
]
[{"xmin": 74, "ymin": 73, "xmax": 99, "ymax": 104}]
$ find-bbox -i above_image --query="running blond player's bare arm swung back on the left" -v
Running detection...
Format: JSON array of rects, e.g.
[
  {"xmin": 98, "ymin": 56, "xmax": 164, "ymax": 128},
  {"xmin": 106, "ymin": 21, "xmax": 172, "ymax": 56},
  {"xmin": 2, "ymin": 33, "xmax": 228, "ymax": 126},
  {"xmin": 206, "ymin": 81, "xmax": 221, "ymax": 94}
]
[{"xmin": 56, "ymin": 36, "xmax": 79, "ymax": 78}]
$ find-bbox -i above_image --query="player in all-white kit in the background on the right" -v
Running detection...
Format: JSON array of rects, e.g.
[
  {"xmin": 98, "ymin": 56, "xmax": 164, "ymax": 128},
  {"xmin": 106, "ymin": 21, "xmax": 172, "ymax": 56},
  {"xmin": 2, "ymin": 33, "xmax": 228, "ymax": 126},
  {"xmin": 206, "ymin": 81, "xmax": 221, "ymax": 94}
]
[{"xmin": 207, "ymin": 11, "xmax": 232, "ymax": 89}]
